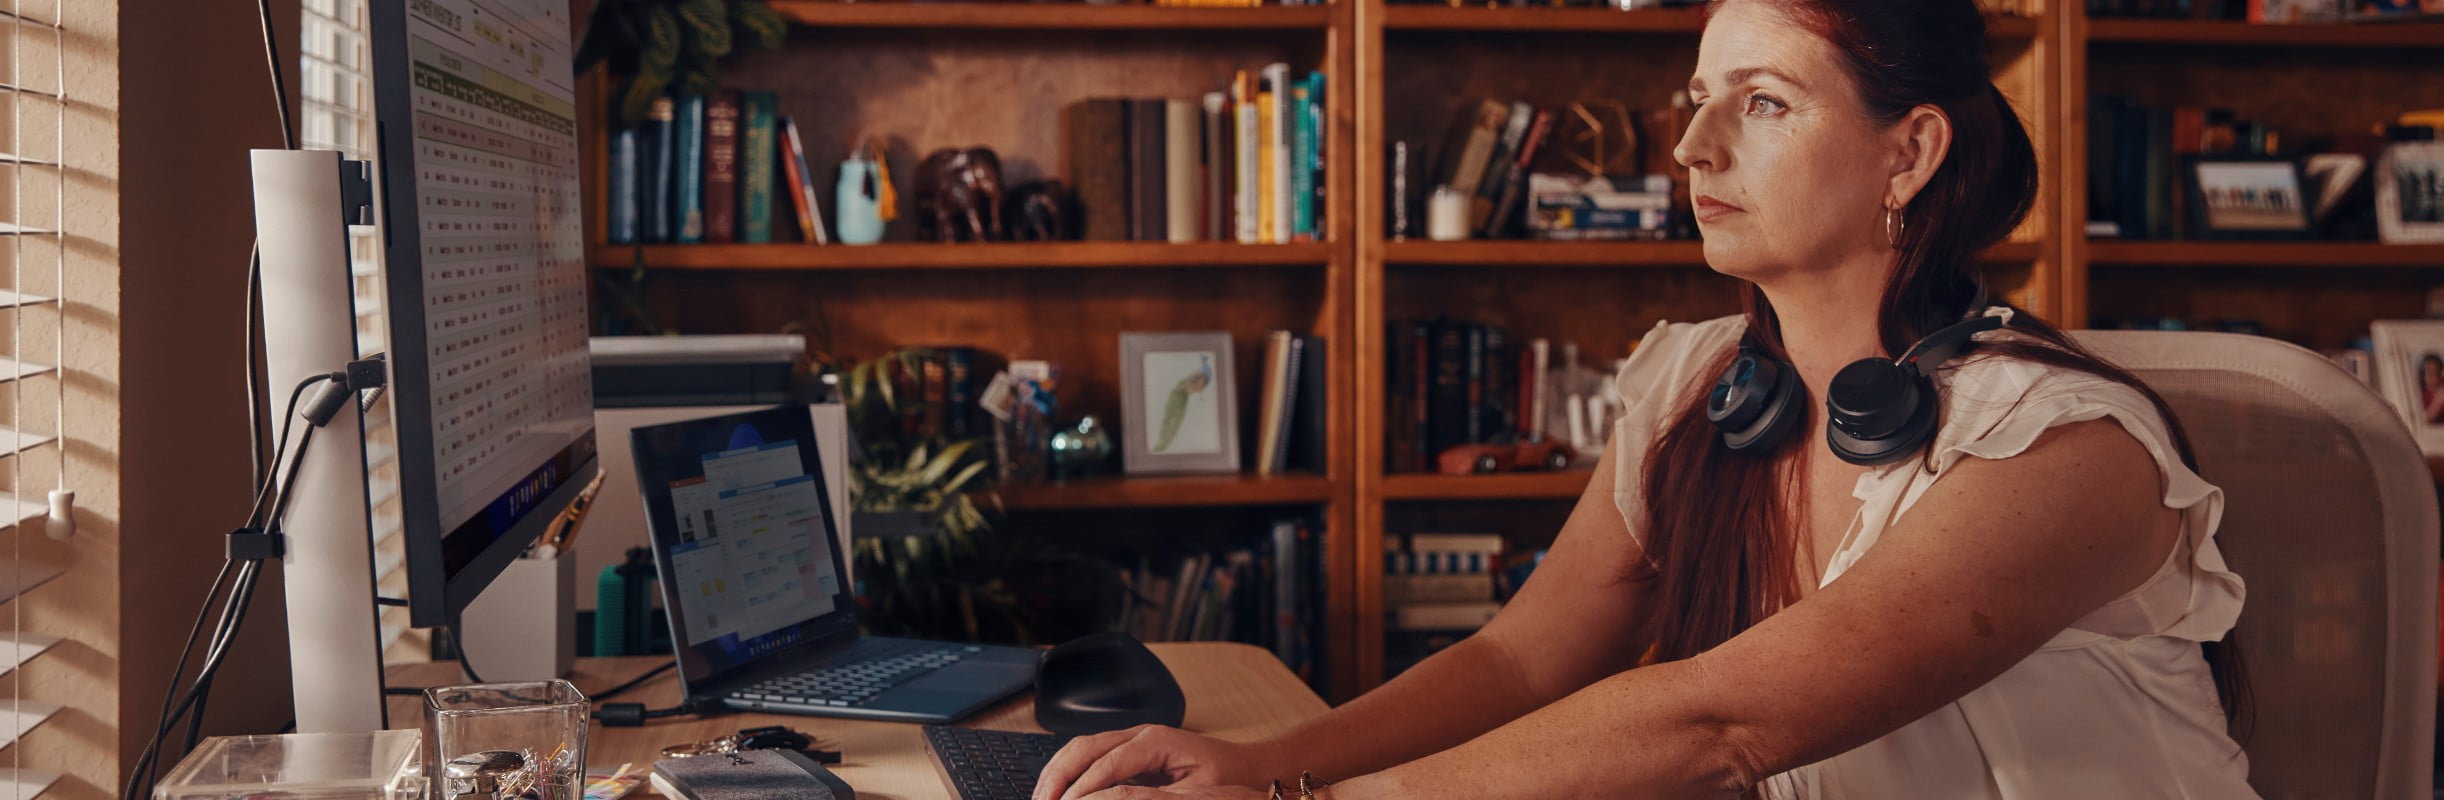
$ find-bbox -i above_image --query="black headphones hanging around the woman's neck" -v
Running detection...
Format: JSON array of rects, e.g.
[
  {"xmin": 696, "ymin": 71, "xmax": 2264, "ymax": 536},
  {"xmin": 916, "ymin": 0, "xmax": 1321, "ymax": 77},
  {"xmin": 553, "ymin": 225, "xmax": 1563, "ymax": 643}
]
[{"xmin": 1706, "ymin": 286, "xmax": 2004, "ymax": 467}]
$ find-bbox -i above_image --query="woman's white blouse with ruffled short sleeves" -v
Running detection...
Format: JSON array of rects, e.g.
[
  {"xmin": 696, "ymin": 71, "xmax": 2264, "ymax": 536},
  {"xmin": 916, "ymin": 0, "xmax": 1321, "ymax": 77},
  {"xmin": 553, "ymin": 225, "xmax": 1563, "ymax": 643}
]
[{"xmin": 1613, "ymin": 308, "xmax": 2256, "ymax": 800}]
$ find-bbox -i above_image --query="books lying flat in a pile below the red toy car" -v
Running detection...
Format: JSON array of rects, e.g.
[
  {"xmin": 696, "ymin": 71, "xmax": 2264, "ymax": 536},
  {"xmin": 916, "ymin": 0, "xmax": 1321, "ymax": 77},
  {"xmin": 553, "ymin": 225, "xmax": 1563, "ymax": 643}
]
[{"xmin": 1383, "ymin": 533, "xmax": 1503, "ymax": 673}]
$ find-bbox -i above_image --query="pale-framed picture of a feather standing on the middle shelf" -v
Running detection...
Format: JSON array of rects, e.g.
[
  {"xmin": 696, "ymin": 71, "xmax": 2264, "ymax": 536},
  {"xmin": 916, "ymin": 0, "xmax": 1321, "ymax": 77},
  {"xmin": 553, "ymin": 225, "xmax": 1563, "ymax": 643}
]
[{"xmin": 1119, "ymin": 330, "xmax": 1239, "ymax": 475}]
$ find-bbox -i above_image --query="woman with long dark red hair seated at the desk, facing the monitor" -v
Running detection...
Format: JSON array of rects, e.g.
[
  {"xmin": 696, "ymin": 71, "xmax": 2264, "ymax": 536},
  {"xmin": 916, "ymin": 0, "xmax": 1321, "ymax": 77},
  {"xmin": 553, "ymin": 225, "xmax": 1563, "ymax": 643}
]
[{"xmin": 1036, "ymin": 0, "xmax": 2253, "ymax": 800}]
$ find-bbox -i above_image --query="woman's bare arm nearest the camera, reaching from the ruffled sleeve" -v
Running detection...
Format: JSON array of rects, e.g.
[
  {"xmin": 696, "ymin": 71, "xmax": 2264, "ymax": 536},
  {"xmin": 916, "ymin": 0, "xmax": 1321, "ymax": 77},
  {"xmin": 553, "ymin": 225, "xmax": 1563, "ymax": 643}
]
[{"xmin": 1327, "ymin": 421, "xmax": 2180, "ymax": 800}]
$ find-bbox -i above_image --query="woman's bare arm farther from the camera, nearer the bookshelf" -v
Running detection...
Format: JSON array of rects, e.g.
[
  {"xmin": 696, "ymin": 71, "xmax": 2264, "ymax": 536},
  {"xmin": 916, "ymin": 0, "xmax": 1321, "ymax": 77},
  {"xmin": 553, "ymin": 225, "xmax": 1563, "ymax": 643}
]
[{"xmin": 1241, "ymin": 435, "xmax": 1652, "ymax": 778}]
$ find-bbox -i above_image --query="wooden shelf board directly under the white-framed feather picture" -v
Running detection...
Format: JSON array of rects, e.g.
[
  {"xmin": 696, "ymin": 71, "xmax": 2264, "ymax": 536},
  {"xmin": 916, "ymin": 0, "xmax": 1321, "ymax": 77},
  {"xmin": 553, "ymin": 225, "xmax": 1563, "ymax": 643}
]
[{"xmin": 995, "ymin": 475, "xmax": 1332, "ymax": 511}]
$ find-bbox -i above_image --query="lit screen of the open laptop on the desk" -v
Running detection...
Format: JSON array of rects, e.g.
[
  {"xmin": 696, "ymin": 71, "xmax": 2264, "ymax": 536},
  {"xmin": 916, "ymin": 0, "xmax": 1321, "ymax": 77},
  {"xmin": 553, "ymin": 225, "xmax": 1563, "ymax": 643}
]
[{"xmin": 631, "ymin": 406, "xmax": 858, "ymax": 685}]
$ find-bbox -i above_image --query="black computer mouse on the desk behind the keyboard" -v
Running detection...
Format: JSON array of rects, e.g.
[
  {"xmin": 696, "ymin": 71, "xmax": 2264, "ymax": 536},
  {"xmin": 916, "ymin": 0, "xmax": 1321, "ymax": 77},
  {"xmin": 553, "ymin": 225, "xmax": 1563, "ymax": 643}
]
[{"xmin": 1036, "ymin": 634, "xmax": 1188, "ymax": 736}]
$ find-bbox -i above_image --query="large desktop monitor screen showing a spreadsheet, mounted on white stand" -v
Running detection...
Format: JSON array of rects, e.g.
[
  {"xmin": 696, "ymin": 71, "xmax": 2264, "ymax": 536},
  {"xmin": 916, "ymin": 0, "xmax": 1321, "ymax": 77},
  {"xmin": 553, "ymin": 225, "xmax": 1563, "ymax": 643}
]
[{"xmin": 369, "ymin": 0, "xmax": 594, "ymax": 624}]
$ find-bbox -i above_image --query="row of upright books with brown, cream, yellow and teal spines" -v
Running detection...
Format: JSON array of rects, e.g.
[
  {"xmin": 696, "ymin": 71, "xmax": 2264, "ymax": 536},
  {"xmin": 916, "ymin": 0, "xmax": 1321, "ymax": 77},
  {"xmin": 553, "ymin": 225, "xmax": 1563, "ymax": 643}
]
[{"xmin": 1063, "ymin": 64, "xmax": 1327, "ymax": 245}]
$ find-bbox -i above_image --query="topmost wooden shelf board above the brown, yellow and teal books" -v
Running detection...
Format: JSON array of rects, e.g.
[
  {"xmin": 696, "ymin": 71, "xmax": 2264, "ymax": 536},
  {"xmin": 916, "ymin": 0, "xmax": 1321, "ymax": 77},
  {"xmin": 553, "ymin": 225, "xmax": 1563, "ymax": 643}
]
[{"xmin": 772, "ymin": 0, "xmax": 1332, "ymax": 29}]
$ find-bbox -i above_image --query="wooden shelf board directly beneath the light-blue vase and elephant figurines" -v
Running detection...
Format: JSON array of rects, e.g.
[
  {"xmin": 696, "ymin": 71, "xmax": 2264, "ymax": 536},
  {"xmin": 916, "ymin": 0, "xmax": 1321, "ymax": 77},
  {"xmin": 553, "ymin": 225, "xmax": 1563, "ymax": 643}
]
[{"xmin": 589, "ymin": 242, "xmax": 1332, "ymax": 269}]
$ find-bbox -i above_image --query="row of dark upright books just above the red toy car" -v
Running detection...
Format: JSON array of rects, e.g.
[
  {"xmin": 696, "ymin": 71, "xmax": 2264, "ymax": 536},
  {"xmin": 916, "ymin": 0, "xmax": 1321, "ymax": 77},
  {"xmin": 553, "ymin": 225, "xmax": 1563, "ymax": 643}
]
[{"xmin": 1383, "ymin": 318, "xmax": 1557, "ymax": 472}]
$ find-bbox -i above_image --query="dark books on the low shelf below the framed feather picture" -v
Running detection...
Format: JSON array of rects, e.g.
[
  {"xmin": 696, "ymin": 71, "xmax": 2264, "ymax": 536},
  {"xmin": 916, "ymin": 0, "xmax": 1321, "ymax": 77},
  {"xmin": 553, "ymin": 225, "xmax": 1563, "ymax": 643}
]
[{"xmin": 1119, "ymin": 519, "xmax": 1325, "ymax": 680}]
